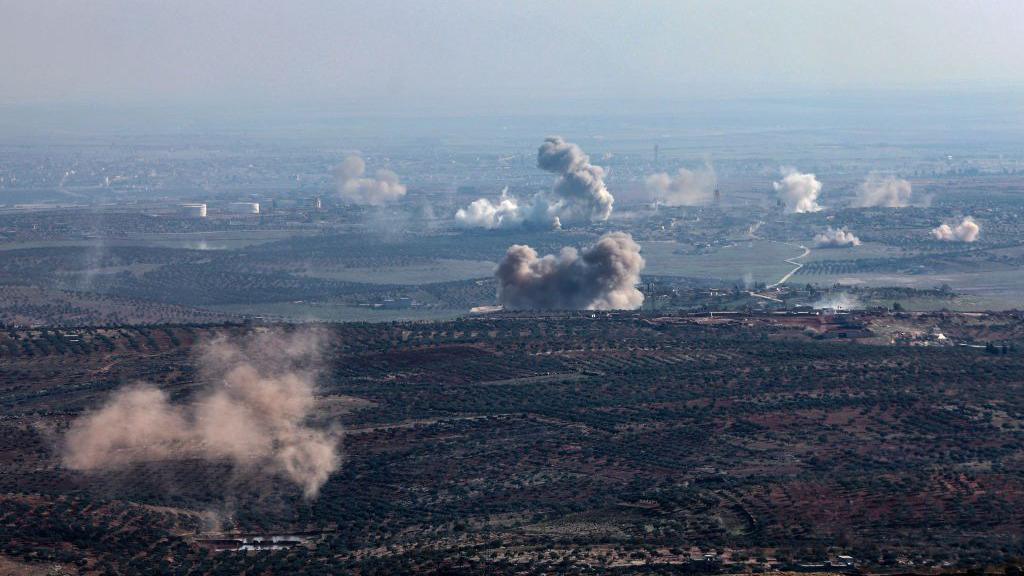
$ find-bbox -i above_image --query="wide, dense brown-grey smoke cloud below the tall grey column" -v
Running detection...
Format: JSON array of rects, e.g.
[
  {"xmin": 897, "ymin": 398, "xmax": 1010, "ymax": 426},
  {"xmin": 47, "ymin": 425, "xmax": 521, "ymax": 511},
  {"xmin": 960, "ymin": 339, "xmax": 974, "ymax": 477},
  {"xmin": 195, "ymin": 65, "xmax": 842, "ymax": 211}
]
[{"xmin": 495, "ymin": 232, "xmax": 644, "ymax": 310}]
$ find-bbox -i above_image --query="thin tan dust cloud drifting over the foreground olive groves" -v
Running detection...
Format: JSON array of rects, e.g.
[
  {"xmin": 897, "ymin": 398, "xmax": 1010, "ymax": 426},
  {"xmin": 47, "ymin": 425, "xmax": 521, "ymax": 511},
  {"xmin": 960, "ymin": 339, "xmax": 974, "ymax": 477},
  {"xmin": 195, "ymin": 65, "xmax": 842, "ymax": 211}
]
[{"xmin": 63, "ymin": 332, "xmax": 341, "ymax": 498}]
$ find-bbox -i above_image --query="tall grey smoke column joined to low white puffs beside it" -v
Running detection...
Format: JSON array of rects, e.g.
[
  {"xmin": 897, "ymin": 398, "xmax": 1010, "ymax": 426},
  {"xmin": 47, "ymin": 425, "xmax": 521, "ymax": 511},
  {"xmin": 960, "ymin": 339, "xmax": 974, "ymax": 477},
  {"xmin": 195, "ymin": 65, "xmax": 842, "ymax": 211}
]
[{"xmin": 456, "ymin": 136, "xmax": 615, "ymax": 229}]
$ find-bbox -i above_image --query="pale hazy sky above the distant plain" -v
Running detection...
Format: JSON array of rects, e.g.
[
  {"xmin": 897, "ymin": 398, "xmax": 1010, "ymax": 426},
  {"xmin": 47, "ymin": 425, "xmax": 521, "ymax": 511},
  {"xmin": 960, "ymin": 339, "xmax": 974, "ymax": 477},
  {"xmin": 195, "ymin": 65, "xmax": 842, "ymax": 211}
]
[{"xmin": 0, "ymin": 0, "xmax": 1024, "ymax": 112}]
